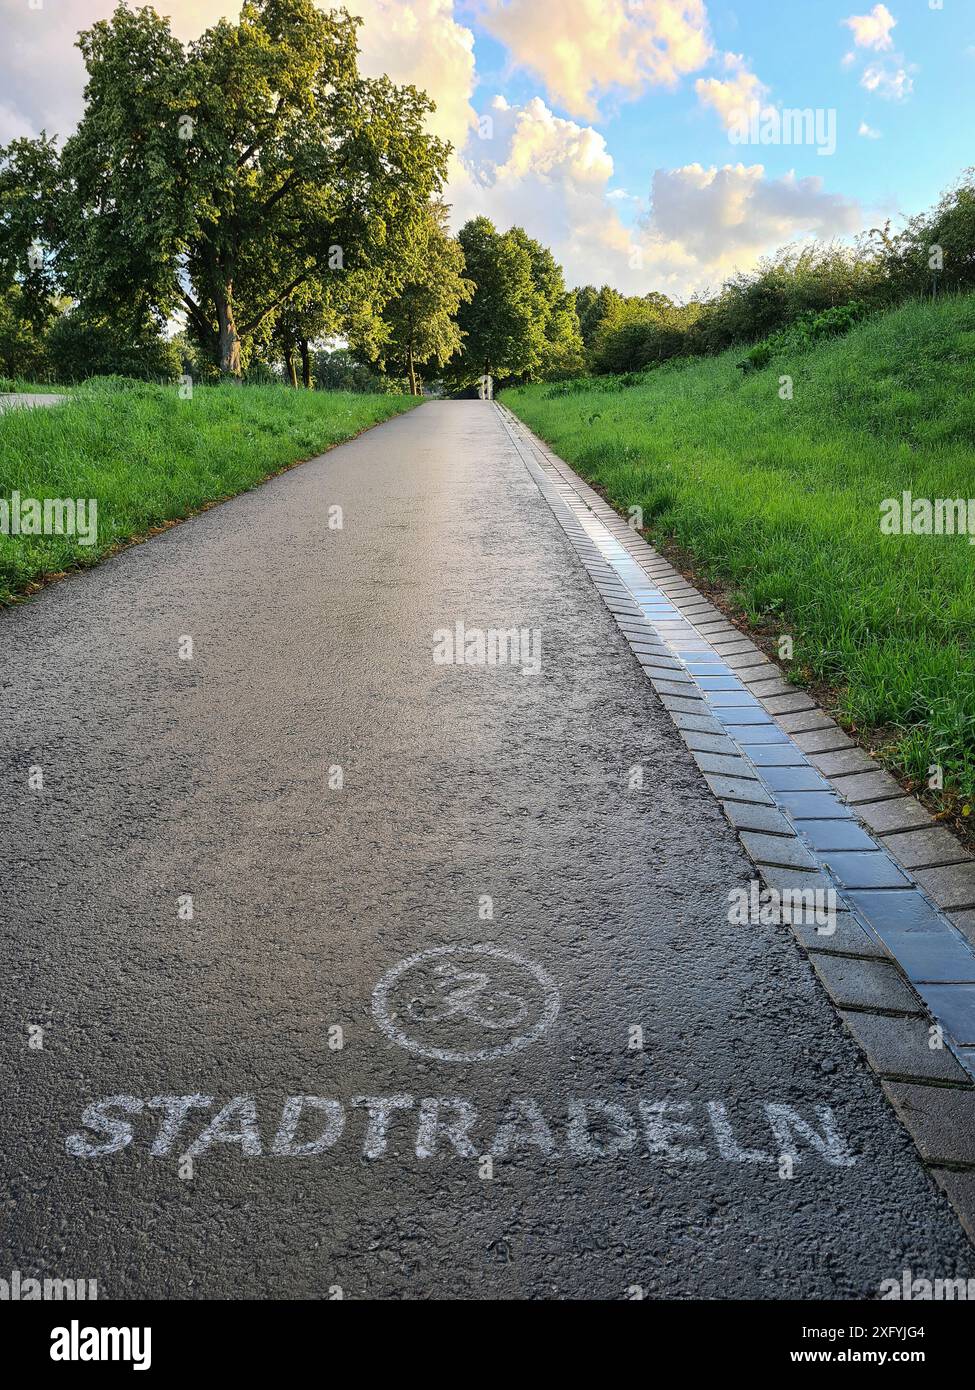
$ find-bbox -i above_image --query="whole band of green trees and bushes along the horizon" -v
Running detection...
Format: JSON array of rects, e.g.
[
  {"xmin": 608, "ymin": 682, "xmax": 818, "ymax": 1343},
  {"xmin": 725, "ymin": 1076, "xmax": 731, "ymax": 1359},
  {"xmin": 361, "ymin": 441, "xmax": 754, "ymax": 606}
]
[{"xmin": 0, "ymin": 0, "xmax": 975, "ymax": 393}]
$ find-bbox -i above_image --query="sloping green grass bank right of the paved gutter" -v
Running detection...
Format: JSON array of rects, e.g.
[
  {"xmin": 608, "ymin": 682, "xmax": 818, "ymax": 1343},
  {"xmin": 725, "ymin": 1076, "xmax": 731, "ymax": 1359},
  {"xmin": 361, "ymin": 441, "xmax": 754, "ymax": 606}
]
[{"xmin": 503, "ymin": 296, "xmax": 975, "ymax": 813}]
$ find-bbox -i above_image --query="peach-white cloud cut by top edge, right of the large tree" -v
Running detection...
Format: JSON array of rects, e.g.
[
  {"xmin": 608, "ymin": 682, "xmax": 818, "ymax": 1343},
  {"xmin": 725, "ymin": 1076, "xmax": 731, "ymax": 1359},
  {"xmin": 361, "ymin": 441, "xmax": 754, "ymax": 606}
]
[{"xmin": 478, "ymin": 0, "xmax": 712, "ymax": 120}]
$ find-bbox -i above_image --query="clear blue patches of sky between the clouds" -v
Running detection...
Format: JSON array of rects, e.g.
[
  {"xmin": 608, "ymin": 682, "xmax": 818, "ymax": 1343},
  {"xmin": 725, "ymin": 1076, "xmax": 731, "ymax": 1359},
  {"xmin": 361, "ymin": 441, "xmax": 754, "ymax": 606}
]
[{"xmin": 460, "ymin": 0, "xmax": 975, "ymax": 225}]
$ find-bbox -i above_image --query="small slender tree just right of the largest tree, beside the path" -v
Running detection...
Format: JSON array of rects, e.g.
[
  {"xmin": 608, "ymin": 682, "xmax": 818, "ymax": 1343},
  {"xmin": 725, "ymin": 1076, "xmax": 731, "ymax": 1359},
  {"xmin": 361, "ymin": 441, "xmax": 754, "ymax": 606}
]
[{"xmin": 381, "ymin": 203, "xmax": 474, "ymax": 396}]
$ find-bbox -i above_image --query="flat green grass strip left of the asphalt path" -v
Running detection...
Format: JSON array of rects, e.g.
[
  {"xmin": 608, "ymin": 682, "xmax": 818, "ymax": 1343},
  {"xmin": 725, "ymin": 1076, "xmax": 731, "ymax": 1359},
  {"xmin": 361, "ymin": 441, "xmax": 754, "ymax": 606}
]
[{"xmin": 0, "ymin": 382, "xmax": 417, "ymax": 605}]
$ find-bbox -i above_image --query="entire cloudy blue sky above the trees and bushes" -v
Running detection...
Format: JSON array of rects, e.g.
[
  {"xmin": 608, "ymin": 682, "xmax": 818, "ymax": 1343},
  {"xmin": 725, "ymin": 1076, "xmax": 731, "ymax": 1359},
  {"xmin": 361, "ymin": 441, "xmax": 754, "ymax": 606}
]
[{"xmin": 0, "ymin": 0, "xmax": 975, "ymax": 297}]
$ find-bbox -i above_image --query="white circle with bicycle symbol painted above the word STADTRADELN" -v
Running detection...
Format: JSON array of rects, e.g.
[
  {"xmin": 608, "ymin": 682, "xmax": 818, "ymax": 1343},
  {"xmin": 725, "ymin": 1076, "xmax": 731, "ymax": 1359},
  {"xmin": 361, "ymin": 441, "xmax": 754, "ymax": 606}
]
[{"xmin": 373, "ymin": 944, "xmax": 561, "ymax": 1062}]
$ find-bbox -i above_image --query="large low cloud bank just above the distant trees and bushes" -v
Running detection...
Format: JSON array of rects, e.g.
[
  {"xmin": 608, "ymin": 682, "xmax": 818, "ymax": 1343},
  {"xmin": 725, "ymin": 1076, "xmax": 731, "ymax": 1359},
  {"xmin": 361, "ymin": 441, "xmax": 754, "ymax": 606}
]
[{"xmin": 449, "ymin": 97, "xmax": 862, "ymax": 295}]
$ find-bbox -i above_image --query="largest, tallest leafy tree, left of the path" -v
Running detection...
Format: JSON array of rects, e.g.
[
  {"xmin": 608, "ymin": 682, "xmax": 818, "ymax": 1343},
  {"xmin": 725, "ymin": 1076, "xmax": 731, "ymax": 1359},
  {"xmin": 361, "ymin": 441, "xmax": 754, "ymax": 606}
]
[{"xmin": 40, "ymin": 0, "xmax": 448, "ymax": 377}]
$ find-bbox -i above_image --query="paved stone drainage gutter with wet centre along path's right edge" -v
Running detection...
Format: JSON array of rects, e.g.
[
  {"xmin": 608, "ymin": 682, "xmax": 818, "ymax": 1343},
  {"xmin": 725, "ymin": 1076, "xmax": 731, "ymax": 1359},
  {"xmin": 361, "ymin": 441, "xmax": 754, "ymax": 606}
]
[{"xmin": 492, "ymin": 403, "xmax": 975, "ymax": 1241}]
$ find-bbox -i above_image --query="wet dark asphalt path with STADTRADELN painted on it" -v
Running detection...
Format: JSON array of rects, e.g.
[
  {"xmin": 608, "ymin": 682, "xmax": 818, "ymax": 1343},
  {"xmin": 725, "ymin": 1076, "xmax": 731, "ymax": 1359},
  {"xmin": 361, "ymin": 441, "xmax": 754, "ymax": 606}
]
[{"xmin": 0, "ymin": 402, "xmax": 971, "ymax": 1298}]
